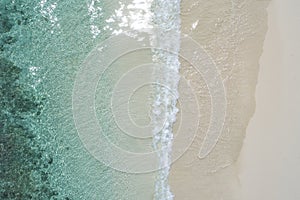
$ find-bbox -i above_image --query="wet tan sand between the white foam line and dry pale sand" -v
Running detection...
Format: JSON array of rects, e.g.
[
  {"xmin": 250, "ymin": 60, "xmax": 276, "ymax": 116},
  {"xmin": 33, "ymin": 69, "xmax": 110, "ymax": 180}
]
[{"xmin": 169, "ymin": 0, "xmax": 268, "ymax": 200}]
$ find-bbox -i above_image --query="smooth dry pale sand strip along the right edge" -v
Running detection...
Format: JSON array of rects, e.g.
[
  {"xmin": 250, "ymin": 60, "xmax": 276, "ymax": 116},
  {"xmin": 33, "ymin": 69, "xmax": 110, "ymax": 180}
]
[{"xmin": 239, "ymin": 0, "xmax": 300, "ymax": 200}]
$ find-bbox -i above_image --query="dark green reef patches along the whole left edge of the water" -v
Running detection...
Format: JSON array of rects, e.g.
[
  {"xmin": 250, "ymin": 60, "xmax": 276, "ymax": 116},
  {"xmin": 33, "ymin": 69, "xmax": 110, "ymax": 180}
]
[{"xmin": 0, "ymin": 0, "xmax": 63, "ymax": 200}]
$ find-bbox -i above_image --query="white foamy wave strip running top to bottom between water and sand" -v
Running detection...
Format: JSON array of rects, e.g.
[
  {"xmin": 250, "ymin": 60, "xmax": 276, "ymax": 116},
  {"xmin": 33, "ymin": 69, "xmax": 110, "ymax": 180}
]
[{"xmin": 151, "ymin": 0, "xmax": 180, "ymax": 200}]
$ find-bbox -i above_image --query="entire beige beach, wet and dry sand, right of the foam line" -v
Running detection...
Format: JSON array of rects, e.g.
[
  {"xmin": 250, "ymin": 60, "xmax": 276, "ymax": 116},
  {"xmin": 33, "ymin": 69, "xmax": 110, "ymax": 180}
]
[{"xmin": 169, "ymin": 0, "xmax": 300, "ymax": 200}]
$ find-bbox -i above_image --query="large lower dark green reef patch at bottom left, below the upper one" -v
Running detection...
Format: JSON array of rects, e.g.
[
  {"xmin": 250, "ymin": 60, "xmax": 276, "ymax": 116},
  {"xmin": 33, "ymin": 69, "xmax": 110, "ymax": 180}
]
[{"xmin": 0, "ymin": 58, "xmax": 58, "ymax": 199}]
